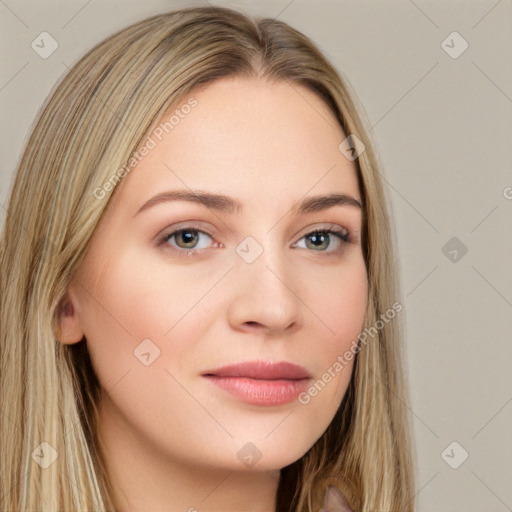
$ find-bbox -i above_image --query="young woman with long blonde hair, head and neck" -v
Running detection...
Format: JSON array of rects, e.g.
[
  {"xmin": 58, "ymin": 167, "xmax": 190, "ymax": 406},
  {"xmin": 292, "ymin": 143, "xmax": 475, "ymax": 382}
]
[{"xmin": 0, "ymin": 8, "xmax": 414, "ymax": 512}]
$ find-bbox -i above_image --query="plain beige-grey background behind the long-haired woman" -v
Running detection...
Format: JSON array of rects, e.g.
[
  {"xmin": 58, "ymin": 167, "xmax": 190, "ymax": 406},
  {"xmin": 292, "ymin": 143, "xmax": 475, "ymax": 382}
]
[{"xmin": 0, "ymin": 0, "xmax": 512, "ymax": 512}]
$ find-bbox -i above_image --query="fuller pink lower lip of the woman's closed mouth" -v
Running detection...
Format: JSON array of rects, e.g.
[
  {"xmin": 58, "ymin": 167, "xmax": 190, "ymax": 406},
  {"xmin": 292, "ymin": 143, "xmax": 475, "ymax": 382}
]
[{"xmin": 206, "ymin": 375, "xmax": 310, "ymax": 405}]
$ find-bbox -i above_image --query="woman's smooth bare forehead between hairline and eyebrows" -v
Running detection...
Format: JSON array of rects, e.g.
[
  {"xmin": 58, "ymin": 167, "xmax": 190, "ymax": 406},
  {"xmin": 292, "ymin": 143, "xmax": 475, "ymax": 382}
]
[{"xmin": 113, "ymin": 78, "xmax": 360, "ymax": 207}]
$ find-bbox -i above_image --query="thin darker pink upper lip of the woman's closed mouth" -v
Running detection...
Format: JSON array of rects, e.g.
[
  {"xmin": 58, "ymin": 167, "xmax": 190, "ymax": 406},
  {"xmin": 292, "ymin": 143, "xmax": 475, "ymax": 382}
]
[{"xmin": 203, "ymin": 361, "xmax": 311, "ymax": 380}]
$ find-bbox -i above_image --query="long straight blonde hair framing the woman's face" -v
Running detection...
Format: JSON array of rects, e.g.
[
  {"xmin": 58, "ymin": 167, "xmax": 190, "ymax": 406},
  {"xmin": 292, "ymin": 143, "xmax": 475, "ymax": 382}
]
[{"xmin": 0, "ymin": 7, "xmax": 414, "ymax": 512}]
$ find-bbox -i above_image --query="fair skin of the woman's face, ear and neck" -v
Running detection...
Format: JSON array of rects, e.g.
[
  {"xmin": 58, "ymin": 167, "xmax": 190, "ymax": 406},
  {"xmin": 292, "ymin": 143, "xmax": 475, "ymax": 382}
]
[{"xmin": 59, "ymin": 78, "xmax": 367, "ymax": 512}]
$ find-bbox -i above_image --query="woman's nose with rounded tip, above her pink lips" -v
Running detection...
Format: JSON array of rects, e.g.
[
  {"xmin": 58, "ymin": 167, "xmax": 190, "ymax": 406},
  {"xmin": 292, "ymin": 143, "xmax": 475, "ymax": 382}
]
[{"xmin": 228, "ymin": 252, "xmax": 304, "ymax": 336}]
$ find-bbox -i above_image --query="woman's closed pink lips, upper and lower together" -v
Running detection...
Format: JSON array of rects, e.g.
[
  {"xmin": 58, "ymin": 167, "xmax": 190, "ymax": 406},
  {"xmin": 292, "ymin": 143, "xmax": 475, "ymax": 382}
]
[{"xmin": 202, "ymin": 361, "xmax": 311, "ymax": 406}]
